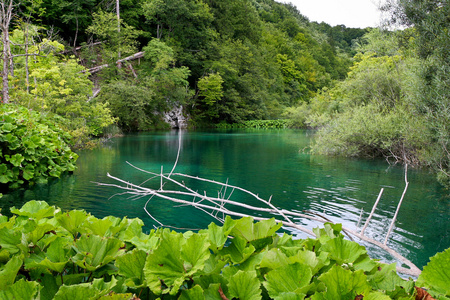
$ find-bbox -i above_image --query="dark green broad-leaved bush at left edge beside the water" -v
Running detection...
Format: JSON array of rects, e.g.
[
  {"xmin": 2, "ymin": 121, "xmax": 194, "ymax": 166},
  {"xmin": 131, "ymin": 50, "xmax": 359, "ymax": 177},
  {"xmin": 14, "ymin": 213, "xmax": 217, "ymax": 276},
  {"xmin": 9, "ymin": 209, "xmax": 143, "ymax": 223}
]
[{"xmin": 0, "ymin": 104, "xmax": 78, "ymax": 188}]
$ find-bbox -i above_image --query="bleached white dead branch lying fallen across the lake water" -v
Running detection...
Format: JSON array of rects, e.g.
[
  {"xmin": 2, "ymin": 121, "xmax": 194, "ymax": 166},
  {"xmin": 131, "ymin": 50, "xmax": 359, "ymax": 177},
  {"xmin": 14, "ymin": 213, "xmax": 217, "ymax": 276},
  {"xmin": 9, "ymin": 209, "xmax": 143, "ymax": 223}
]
[{"xmin": 98, "ymin": 135, "xmax": 421, "ymax": 277}]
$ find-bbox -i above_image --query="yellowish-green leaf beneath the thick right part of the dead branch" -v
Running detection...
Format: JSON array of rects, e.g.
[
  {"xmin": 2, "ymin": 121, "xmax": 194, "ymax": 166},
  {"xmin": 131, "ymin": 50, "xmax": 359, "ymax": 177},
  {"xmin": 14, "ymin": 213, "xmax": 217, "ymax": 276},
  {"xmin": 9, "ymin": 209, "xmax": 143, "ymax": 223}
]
[{"xmin": 320, "ymin": 237, "xmax": 367, "ymax": 265}]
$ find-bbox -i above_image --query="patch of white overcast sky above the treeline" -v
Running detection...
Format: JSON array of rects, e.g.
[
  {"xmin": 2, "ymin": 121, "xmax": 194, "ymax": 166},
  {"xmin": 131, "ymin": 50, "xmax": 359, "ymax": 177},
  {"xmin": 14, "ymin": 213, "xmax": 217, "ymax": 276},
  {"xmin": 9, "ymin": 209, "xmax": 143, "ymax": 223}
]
[{"xmin": 276, "ymin": 0, "xmax": 381, "ymax": 28}]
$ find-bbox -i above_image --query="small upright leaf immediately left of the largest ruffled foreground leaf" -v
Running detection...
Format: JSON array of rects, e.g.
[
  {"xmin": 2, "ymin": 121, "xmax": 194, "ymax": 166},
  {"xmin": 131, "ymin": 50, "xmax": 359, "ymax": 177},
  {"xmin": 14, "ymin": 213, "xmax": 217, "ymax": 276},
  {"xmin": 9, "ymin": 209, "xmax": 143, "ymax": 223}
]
[{"xmin": 115, "ymin": 249, "xmax": 147, "ymax": 288}]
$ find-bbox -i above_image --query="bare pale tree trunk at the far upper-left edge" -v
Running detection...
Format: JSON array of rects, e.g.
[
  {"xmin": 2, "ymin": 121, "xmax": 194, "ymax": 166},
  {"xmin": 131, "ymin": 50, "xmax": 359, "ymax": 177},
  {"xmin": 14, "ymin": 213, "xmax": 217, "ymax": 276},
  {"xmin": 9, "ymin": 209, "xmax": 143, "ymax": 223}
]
[{"xmin": 0, "ymin": 0, "xmax": 14, "ymax": 103}]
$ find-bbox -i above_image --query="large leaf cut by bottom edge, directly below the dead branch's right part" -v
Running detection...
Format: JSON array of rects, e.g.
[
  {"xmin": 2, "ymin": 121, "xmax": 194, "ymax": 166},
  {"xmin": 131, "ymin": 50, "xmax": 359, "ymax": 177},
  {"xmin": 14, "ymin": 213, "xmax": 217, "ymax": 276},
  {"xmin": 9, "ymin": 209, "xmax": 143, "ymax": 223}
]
[{"xmin": 311, "ymin": 265, "xmax": 371, "ymax": 300}]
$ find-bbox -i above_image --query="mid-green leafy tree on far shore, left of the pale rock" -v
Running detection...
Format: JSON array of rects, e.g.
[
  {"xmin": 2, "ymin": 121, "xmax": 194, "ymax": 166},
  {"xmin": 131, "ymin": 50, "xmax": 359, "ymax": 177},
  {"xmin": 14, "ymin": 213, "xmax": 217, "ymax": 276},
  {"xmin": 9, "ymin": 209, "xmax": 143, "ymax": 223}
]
[{"xmin": 99, "ymin": 39, "xmax": 193, "ymax": 131}]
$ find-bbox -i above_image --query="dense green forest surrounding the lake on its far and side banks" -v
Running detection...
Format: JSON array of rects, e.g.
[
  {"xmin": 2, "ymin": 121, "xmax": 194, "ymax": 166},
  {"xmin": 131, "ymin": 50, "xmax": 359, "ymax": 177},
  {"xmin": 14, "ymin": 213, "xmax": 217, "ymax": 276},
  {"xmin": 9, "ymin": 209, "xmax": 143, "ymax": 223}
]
[{"xmin": 0, "ymin": 0, "xmax": 450, "ymax": 187}]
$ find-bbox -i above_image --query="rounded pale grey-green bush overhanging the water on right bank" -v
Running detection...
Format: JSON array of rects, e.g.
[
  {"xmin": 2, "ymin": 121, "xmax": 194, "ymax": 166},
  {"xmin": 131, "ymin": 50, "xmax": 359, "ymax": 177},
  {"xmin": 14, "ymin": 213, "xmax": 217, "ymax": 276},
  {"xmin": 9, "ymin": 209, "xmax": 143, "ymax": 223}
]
[{"xmin": 312, "ymin": 104, "xmax": 430, "ymax": 164}]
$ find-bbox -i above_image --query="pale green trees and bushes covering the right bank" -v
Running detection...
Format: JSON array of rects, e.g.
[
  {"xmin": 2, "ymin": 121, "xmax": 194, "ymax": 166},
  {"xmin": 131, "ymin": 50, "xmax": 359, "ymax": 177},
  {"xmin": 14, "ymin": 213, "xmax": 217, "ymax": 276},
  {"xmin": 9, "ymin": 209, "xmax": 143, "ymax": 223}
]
[{"xmin": 302, "ymin": 14, "xmax": 450, "ymax": 186}]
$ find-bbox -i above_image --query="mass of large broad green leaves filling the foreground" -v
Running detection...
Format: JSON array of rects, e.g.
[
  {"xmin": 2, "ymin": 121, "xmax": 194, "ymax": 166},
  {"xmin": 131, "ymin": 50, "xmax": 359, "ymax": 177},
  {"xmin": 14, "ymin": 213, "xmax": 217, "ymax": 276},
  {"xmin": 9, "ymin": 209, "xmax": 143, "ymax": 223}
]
[{"xmin": 0, "ymin": 201, "xmax": 450, "ymax": 300}]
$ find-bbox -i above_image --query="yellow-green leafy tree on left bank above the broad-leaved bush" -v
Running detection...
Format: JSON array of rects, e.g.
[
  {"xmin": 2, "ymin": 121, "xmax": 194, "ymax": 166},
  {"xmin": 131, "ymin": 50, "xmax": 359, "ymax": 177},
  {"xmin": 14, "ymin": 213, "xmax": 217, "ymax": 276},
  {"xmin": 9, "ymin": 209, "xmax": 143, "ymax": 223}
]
[{"xmin": 10, "ymin": 28, "xmax": 115, "ymax": 141}]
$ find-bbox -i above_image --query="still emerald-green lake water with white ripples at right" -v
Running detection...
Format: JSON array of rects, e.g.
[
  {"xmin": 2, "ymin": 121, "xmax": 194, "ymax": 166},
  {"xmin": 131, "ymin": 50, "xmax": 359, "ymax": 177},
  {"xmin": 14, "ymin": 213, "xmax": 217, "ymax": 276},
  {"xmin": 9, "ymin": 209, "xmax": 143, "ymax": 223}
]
[{"xmin": 0, "ymin": 130, "xmax": 450, "ymax": 268}]
